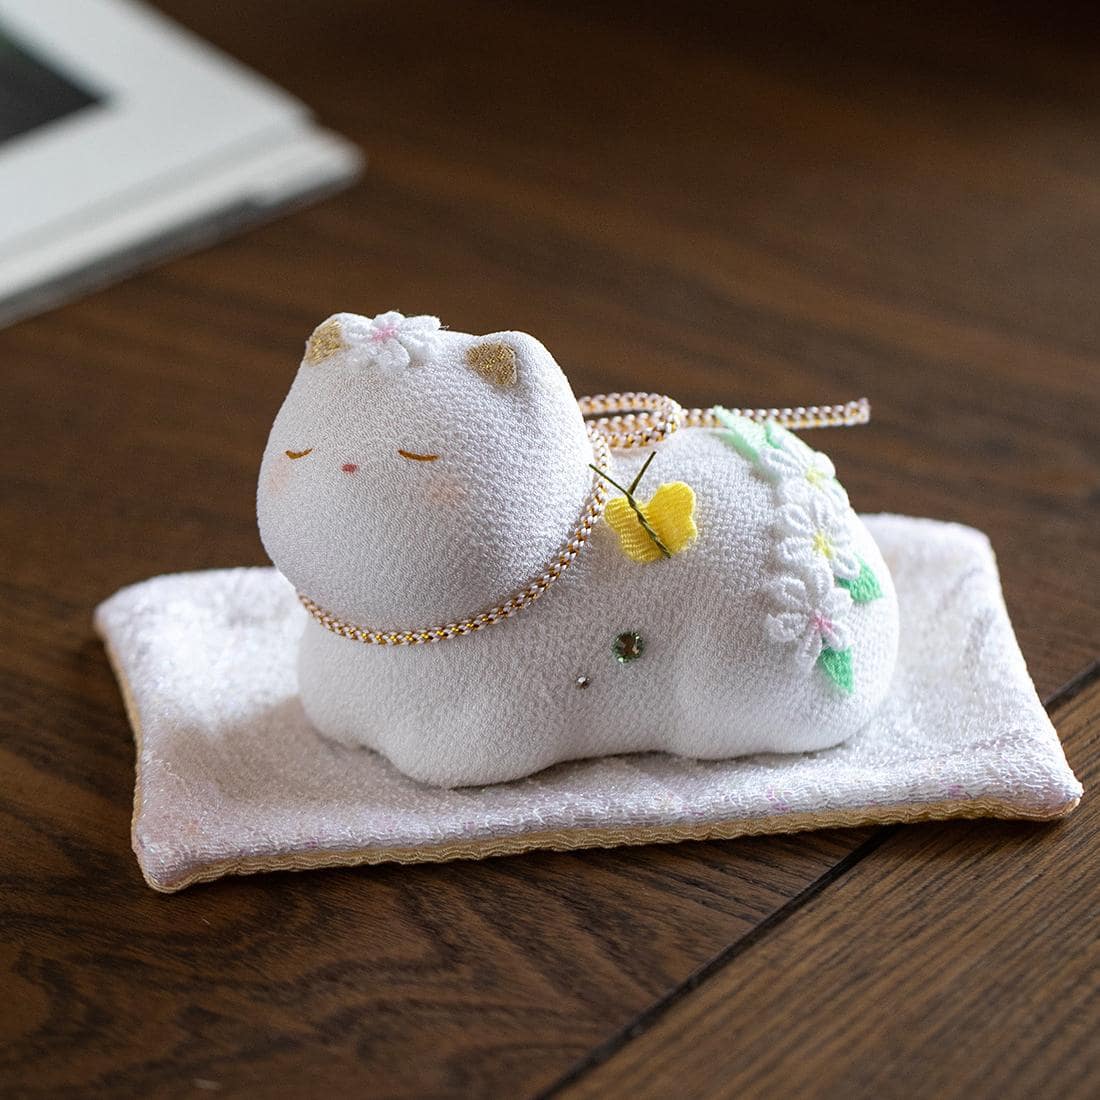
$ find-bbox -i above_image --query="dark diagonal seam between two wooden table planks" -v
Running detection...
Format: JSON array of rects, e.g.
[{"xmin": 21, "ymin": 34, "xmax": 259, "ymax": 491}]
[{"xmin": 537, "ymin": 659, "xmax": 1100, "ymax": 1100}]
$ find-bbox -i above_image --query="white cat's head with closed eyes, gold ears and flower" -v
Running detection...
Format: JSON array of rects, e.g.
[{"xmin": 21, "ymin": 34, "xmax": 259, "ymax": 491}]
[{"xmin": 257, "ymin": 312, "xmax": 592, "ymax": 629}]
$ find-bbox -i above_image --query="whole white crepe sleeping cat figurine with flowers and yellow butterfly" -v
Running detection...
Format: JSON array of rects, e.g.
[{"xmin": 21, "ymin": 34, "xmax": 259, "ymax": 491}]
[{"xmin": 259, "ymin": 312, "xmax": 898, "ymax": 787}]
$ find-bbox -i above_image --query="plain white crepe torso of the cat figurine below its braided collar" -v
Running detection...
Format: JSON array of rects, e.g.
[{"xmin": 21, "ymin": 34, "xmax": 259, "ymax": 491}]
[{"xmin": 298, "ymin": 431, "xmax": 898, "ymax": 787}]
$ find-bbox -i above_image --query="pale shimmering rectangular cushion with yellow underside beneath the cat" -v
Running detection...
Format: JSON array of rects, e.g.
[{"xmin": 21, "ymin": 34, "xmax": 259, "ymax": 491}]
[{"xmin": 96, "ymin": 516, "xmax": 1081, "ymax": 891}]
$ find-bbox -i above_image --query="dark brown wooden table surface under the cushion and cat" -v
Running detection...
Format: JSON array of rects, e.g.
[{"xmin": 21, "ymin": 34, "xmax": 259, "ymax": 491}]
[{"xmin": 0, "ymin": 0, "xmax": 1100, "ymax": 1097}]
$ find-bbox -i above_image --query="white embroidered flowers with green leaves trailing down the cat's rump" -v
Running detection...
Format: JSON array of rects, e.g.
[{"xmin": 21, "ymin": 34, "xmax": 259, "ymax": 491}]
[{"xmin": 715, "ymin": 409, "xmax": 882, "ymax": 694}]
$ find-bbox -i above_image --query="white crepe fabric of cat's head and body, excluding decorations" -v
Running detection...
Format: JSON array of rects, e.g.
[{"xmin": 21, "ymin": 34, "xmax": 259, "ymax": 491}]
[{"xmin": 260, "ymin": 315, "xmax": 898, "ymax": 787}]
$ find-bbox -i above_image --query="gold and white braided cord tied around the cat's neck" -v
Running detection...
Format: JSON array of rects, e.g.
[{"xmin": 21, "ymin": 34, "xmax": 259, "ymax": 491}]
[{"xmin": 298, "ymin": 393, "xmax": 871, "ymax": 646}]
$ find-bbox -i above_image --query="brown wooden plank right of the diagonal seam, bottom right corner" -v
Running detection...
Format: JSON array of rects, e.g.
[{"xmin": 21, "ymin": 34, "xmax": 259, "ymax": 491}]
[{"xmin": 558, "ymin": 681, "xmax": 1100, "ymax": 1100}]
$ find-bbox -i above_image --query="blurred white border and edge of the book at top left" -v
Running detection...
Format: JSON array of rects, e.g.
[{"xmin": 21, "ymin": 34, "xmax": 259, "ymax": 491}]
[{"xmin": 0, "ymin": 0, "xmax": 362, "ymax": 325}]
